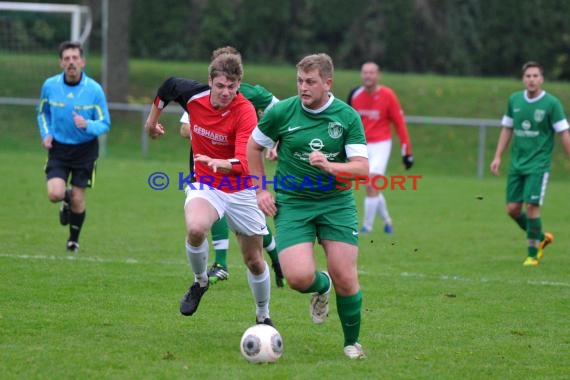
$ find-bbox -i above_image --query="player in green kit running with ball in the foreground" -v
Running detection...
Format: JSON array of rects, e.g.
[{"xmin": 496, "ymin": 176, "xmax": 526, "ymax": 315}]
[{"xmin": 247, "ymin": 54, "xmax": 368, "ymax": 359}]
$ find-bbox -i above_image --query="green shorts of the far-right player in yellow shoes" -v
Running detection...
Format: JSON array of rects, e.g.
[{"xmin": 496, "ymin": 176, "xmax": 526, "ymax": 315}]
[{"xmin": 507, "ymin": 172, "xmax": 548, "ymax": 206}]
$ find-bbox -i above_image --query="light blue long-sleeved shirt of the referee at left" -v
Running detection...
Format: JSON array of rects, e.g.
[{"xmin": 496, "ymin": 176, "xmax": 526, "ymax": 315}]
[{"xmin": 37, "ymin": 72, "xmax": 111, "ymax": 144}]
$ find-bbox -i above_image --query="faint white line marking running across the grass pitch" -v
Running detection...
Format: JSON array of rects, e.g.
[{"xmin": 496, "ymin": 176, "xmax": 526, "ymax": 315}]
[{"xmin": 4, "ymin": 253, "xmax": 570, "ymax": 287}]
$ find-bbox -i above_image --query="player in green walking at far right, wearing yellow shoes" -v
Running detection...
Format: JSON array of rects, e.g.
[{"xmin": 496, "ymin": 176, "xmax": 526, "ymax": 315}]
[{"xmin": 491, "ymin": 62, "xmax": 570, "ymax": 266}]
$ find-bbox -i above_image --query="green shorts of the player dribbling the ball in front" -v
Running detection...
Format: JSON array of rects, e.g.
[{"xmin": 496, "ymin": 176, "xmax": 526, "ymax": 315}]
[{"xmin": 274, "ymin": 197, "xmax": 358, "ymax": 251}]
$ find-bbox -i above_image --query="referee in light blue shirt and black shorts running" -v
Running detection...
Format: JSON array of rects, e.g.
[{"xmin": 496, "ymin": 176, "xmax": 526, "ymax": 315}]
[{"xmin": 37, "ymin": 41, "xmax": 111, "ymax": 252}]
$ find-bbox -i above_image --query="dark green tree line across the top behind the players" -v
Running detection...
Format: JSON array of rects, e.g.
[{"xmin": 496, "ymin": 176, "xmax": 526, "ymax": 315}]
[{"xmin": 4, "ymin": 0, "xmax": 570, "ymax": 99}]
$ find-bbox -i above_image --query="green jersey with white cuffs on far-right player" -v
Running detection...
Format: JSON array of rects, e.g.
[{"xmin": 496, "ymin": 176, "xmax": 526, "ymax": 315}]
[{"xmin": 501, "ymin": 91, "xmax": 568, "ymax": 174}]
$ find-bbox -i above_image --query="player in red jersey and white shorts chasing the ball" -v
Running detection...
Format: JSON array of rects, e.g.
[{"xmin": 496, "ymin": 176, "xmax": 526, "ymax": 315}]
[{"xmin": 145, "ymin": 47, "xmax": 273, "ymax": 325}]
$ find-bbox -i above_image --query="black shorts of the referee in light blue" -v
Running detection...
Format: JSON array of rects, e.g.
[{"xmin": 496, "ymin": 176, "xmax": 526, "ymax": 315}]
[{"xmin": 45, "ymin": 139, "xmax": 99, "ymax": 188}]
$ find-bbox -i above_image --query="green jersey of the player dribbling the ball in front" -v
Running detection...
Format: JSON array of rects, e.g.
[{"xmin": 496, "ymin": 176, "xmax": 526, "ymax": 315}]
[{"xmin": 252, "ymin": 94, "xmax": 368, "ymax": 201}]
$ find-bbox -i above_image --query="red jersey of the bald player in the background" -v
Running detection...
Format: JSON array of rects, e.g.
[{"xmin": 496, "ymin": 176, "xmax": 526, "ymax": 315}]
[{"xmin": 348, "ymin": 86, "xmax": 412, "ymax": 156}]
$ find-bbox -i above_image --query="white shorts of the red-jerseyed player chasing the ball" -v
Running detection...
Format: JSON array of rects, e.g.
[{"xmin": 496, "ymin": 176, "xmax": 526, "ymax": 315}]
[{"xmin": 184, "ymin": 182, "xmax": 269, "ymax": 236}]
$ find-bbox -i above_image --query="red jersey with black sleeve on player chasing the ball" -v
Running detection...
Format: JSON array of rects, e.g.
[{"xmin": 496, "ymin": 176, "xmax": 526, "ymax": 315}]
[{"xmin": 155, "ymin": 78, "xmax": 257, "ymax": 193}]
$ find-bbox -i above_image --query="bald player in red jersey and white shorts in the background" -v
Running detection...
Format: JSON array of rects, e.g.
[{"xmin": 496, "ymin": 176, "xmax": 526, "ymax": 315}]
[{"xmin": 348, "ymin": 62, "xmax": 414, "ymax": 234}]
